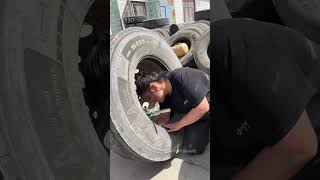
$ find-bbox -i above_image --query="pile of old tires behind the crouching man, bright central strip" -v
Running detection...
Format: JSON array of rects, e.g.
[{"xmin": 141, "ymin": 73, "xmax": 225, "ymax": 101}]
[{"xmin": 134, "ymin": 10, "xmax": 210, "ymax": 74}]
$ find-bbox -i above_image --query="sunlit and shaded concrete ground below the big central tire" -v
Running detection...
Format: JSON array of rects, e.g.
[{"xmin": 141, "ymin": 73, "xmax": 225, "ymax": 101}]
[{"xmin": 110, "ymin": 144, "xmax": 210, "ymax": 180}]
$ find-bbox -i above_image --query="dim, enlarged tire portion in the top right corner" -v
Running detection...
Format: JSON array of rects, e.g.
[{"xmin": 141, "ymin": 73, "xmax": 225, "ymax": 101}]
[{"xmin": 273, "ymin": 0, "xmax": 320, "ymax": 43}]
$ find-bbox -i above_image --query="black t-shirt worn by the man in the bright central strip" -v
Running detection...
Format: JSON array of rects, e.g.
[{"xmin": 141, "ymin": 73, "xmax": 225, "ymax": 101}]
[{"xmin": 160, "ymin": 67, "xmax": 210, "ymax": 114}]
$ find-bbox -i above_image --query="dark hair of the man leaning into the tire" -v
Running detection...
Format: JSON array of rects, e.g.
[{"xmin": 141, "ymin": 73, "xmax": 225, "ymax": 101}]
[{"xmin": 136, "ymin": 71, "xmax": 168, "ymax": 96}]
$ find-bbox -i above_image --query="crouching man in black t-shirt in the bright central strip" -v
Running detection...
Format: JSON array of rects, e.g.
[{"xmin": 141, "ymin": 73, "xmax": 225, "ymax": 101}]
[{"xmin": 136, "ymin": 68, "xmax": 210, "ymax": 153}]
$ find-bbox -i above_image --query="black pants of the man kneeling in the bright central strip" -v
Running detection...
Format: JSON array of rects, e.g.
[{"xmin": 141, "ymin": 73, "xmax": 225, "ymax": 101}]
[{"xmin": 181, "ymin": 113, "xmax": 210, "ymax": 154}]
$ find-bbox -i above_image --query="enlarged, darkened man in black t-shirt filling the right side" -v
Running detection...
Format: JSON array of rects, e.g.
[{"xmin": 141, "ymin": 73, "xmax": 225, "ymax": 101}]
[{"xmin": 209, "ymin": 19, "xmax": 320, "ymax": 180}]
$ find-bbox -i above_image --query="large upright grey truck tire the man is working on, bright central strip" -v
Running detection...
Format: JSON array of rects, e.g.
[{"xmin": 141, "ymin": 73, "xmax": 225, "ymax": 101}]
[{"xmin": 110, "ymin": 28, "xmax": 183, "ymax": 162}]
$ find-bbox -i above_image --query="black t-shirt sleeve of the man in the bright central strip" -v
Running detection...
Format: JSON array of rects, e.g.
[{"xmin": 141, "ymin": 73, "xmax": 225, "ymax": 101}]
[{"xmin": 178, "ymin": 68, "xmax": 209, "ymax": 108}]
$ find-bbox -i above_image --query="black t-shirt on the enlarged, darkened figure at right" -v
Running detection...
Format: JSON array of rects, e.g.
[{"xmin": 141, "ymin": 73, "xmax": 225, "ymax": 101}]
[{"xmin": 210, "ymin": 19, "xmax": 320, "ymax": 166}]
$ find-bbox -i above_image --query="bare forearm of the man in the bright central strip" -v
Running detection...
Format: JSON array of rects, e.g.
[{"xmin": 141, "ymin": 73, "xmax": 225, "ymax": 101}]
[{"xmin": 163, "ymin": 97, "xmax": 209, "ymax": 132}]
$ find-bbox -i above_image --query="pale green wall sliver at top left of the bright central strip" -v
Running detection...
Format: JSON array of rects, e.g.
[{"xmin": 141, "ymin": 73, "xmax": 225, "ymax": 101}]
[{"xmin": 110, "ymin": 0, "xmax": 122, "ymax": 33}]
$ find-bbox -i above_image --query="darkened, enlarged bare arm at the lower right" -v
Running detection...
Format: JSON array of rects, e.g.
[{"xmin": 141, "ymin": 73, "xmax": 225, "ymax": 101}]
[{"xmin": 232, "ymin": 111, "xmax": 318, "ymax": 180}]
